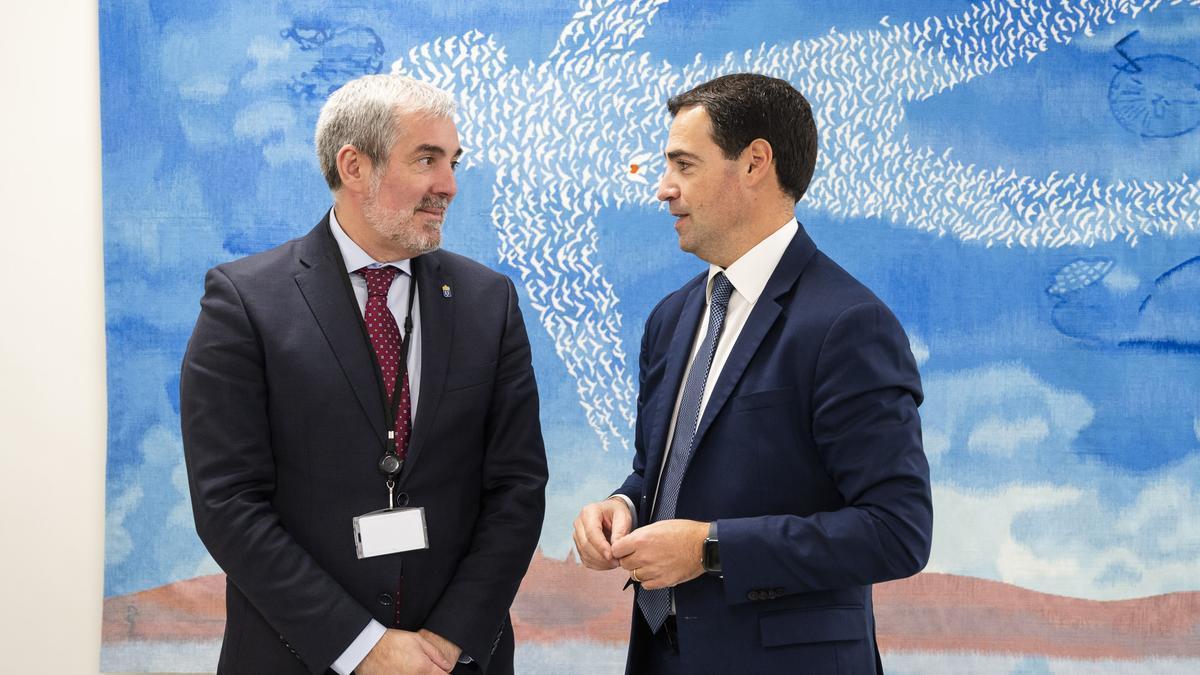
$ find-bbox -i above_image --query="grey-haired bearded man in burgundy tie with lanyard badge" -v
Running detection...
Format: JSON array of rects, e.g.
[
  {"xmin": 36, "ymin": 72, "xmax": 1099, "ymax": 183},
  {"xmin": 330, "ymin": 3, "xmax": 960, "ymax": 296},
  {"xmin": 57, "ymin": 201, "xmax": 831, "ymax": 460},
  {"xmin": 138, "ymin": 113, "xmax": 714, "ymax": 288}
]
[{"xmin": 180, "ymin": 74, "xmax": 546, "ymax": 675}]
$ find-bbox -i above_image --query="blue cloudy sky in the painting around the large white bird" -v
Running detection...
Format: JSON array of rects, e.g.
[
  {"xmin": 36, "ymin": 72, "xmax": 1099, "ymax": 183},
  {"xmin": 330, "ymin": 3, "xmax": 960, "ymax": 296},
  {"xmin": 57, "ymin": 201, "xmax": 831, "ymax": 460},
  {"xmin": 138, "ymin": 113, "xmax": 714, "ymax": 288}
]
[{"xmin": 101, "ymin": 0, "xmax": 1200, "ymax": 598}]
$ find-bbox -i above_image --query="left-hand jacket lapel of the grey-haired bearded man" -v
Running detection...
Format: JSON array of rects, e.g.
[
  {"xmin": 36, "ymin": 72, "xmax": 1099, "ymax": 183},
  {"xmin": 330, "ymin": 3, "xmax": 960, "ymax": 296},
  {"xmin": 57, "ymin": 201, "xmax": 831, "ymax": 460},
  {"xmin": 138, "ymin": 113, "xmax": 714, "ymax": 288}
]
[{"xmin": 295, "ymin": 215, "xmax": 384, "ymax": 442}]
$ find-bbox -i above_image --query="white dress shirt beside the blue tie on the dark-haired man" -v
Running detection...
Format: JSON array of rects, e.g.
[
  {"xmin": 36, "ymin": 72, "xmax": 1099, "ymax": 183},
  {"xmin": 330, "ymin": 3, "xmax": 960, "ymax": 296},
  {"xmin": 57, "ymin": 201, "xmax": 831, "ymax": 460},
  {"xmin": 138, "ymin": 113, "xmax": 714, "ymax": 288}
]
[{"xmin": 613, "ymin": 217, "xmax": 799, "ymax": 527}]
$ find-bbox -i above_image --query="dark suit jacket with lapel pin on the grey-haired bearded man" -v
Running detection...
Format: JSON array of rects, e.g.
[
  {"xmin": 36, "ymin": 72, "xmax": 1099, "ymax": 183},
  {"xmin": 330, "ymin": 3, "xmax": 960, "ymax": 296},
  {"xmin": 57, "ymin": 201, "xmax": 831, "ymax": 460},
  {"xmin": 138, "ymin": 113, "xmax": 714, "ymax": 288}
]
[{"xmin": 180, "ymin": 216, "xmax": 546, "ymax": 675}]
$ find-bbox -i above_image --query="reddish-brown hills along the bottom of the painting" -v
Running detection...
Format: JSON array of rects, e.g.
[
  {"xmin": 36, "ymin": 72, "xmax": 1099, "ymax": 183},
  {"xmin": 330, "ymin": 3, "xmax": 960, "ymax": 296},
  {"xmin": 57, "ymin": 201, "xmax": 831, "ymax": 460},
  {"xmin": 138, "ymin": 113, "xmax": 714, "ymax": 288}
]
[{"xmin": 103, "ymin": 551, "xmax": 1200, "ymax": 659}]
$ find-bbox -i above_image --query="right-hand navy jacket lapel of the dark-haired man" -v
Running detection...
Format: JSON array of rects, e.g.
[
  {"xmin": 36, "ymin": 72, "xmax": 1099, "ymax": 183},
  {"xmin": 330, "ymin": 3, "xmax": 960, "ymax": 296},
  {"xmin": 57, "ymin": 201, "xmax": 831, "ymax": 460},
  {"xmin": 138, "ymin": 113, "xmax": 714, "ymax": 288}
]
[{"xmin": 692, "ymin": 226, "xmax": 816, "ymax": 456}]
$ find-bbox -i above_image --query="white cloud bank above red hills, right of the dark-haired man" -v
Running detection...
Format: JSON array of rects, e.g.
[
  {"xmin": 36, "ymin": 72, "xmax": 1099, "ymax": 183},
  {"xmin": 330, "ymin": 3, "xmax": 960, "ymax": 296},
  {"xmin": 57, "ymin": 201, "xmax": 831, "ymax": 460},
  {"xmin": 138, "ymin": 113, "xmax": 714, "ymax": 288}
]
[{"xmin": 928, "ymin": 459, "xmax": 1200, "ymax": 601}]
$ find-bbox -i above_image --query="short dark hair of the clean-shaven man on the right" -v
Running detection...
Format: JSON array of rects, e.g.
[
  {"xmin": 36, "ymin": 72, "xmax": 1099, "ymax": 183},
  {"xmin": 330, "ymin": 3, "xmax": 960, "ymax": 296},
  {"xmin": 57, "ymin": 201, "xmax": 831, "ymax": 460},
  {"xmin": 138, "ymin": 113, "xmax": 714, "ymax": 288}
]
[{"xmin": 667, "ymin": 73, "xmax": 817, "ymax": 202}]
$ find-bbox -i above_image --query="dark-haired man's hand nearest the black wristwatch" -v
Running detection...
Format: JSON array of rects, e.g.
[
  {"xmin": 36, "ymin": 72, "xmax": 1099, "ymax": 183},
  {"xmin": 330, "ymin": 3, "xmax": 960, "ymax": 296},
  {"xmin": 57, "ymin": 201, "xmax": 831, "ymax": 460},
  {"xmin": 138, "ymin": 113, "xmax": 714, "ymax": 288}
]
[{"xmin": 612, "ymin": 520, "xmax": 708, "ymax": 591}]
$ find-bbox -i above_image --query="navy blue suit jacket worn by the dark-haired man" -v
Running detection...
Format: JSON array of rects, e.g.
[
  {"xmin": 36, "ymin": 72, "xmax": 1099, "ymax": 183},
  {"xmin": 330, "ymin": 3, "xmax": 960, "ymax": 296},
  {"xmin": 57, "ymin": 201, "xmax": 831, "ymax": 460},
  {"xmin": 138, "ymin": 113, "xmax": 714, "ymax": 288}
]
[{"xmin": 618, "ymin": 227, "xmax": 932, "ymax": 674}]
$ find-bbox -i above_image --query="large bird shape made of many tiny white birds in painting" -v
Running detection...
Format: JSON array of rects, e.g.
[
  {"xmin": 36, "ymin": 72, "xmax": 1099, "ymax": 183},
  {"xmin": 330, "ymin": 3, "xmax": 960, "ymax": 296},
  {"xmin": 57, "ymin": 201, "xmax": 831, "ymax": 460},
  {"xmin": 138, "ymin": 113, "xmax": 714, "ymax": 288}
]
[{"xmin": 392, "ymin": 0, "xmax": 1200, "ymax": 448}]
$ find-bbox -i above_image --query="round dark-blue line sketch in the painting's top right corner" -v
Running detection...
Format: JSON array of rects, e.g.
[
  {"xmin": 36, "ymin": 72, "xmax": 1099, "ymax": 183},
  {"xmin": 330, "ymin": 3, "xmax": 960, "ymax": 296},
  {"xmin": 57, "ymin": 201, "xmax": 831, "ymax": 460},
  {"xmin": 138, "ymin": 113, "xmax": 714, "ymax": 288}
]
[{"xmin": 1109, "ymin": 30, "xmax": 1200, "ymax": 138}]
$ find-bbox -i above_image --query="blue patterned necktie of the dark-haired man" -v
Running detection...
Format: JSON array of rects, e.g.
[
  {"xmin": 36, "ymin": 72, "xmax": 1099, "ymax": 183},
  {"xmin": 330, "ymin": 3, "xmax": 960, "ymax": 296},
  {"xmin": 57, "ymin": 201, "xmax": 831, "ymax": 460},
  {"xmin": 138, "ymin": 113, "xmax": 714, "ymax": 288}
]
[{"xmin": 637, "ymin": 273, "xmax": 733, "ymax": 633}]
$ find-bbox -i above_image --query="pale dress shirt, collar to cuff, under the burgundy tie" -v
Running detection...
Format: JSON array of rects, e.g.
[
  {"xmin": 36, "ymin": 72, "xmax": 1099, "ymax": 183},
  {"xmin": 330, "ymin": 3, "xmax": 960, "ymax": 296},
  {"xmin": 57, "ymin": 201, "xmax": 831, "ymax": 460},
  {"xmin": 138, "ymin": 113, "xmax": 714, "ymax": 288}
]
[{"xmin": 329, "ymin": 210, "xmax": 421, "ymax": 675}]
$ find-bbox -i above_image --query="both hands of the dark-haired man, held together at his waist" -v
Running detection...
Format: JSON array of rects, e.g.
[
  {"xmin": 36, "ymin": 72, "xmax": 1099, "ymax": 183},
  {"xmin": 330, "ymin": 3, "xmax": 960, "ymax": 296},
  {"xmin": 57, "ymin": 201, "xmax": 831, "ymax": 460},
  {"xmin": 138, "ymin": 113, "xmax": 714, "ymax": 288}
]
[{"xmin": 575, "ymin": 498, "xmax": 708, "ymax": 590}]
